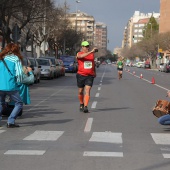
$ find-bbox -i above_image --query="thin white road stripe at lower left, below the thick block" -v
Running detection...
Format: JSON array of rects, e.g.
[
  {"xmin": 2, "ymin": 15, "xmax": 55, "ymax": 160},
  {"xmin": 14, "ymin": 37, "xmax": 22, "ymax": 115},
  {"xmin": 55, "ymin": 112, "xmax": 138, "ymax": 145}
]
[{"xmin": 4, "ymin": 150, "xmax": 45, "ymax": 155}]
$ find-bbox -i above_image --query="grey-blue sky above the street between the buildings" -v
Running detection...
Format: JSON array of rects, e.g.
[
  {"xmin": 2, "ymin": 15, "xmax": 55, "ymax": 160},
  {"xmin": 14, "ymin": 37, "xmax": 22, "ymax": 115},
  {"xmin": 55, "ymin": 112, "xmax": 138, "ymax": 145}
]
[{"xmin": 54, "ymin": 0, "xmax": 160, "ymax": 51}]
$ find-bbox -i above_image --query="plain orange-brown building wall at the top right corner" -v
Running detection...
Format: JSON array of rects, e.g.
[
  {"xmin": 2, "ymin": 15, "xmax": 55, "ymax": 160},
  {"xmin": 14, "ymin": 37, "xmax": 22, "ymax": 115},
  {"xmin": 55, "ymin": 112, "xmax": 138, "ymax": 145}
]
[{"xmin": 159, "ymin": 0, "xmax": 170, "ymax": 33}]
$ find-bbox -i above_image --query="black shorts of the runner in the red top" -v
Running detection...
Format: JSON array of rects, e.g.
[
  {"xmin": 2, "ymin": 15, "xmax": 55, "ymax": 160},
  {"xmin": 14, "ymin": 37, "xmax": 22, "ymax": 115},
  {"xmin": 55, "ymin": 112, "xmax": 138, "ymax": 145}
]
[{"xmin": 76, "ymin": 74, "xmax": 94, "ymax": 88}]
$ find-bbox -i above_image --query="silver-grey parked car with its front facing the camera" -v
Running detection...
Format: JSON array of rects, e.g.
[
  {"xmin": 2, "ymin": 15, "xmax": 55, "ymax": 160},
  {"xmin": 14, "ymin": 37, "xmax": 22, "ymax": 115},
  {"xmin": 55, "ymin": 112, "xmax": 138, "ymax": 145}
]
[{"xmin": 36, "ymin": 58, "xmax": 56, "ymax": 79}]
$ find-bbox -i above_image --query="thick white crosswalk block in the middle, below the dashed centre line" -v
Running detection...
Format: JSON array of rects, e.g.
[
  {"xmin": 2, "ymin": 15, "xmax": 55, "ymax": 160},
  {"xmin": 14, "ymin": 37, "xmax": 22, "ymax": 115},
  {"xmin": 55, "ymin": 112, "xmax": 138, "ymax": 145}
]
[{"xmin": 89, "ymin": 132, "xmax": 122, "ymax": 144}]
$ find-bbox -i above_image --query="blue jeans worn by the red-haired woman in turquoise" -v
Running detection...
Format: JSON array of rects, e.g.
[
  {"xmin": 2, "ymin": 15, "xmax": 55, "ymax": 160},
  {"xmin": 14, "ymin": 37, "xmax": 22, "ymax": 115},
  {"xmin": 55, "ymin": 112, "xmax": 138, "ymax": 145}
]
[{"xmin": 0, "ymin": 91, "xmax": 23, "ymax": 124}]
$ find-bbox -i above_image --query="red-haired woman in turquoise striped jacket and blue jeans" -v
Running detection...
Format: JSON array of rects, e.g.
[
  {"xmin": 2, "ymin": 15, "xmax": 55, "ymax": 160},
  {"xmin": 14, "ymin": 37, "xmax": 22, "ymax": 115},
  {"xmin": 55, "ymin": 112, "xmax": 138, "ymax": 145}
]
[{"xmin": 0, "ymin": 43, "xmax": 23, "ymax": 128}]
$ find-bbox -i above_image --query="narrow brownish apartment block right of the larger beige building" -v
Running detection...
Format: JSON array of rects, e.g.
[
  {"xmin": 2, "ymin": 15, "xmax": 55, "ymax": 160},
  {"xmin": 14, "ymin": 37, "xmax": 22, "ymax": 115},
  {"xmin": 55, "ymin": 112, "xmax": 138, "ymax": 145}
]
[{"xmin": 94, "ymin": 22, "xmax": 107, "ymax": 49}]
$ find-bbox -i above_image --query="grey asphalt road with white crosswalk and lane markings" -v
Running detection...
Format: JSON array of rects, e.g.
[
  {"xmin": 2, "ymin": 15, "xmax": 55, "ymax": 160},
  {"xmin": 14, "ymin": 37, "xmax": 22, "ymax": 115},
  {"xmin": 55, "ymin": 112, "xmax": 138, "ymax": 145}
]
[{"xmin": 0, "ymin": 65, "xmax": 170, "ymax": 170}]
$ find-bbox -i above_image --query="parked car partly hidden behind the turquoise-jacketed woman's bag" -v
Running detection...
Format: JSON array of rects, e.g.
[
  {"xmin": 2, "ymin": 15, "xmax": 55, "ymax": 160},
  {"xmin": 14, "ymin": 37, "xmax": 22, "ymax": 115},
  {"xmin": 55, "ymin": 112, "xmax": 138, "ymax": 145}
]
[{"xmin": 29, "ymin": 58, "xmax": 41, "ymax": 83}]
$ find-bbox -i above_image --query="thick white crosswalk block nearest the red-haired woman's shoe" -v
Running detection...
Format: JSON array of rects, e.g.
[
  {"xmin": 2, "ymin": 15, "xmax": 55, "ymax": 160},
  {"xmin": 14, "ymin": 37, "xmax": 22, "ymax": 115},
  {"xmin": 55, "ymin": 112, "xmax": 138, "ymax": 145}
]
[{"xmin": 23, "ymin": 130, "xmax": 64, "ymax": 141}]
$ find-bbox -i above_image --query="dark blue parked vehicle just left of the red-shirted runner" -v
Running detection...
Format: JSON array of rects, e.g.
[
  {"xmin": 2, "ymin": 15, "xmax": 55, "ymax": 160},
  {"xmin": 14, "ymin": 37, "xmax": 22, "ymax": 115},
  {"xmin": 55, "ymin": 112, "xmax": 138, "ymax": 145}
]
[{"xmin": 60, "ymin": 56, "xmax": 78, "ymax": 73}]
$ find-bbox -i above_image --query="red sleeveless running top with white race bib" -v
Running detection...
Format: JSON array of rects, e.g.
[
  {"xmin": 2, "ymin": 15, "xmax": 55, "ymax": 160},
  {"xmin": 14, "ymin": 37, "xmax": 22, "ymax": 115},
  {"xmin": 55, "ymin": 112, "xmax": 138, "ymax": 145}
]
[{"xmin": 77, "ymin": 51, "xmax": 95, "ymax": 76}]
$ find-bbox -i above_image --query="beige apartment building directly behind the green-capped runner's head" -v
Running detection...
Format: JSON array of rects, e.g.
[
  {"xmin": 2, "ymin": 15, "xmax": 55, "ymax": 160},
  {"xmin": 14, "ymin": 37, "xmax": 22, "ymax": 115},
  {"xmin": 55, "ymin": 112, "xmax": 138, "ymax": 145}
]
[{"xmin": 67, "ymin": 10, "xmax": 95, "ymax": 45}]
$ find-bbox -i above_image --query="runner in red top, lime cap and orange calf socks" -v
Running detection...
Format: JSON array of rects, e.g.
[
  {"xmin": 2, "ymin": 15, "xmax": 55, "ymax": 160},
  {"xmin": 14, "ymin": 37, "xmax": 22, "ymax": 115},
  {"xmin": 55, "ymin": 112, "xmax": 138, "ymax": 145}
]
[{"xmin": 76, "ymin": 41, "xmax": 98, "ymax": 113}]
